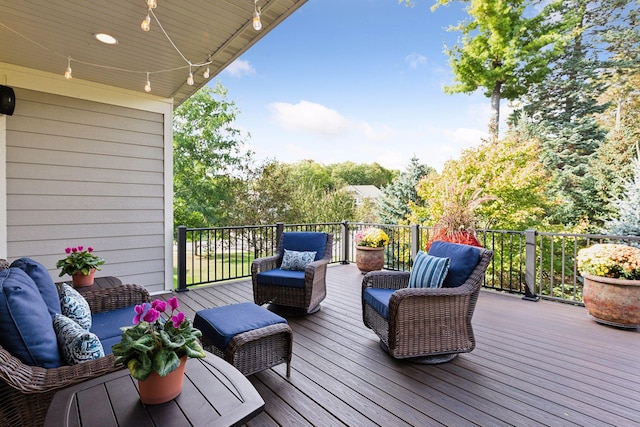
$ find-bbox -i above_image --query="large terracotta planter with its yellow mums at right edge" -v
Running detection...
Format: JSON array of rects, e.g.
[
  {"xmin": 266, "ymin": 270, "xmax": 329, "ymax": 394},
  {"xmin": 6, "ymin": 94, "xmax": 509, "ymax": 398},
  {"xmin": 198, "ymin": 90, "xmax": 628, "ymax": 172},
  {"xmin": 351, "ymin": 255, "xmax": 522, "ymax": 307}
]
[{"xmin": 577, "ymin": 243, "xmax": 640, "ymax": 329}]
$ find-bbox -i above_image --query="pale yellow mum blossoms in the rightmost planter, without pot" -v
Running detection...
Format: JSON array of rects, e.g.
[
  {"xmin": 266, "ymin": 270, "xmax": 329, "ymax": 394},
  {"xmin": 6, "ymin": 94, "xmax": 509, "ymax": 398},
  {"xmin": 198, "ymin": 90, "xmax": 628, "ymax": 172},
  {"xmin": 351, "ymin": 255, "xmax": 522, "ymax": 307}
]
[{"xmin": 577, "ymin": 243, "xmax": 640, "ymax": 280}]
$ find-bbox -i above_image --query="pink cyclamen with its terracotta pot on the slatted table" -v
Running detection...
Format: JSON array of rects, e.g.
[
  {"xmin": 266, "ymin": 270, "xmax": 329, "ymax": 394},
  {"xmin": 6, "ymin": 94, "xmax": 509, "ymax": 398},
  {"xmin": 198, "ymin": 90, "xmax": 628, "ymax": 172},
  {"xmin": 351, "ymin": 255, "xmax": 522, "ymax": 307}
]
[{"xmin": 111, "ymin": 297, "xmax": 205, "ymax": 404}]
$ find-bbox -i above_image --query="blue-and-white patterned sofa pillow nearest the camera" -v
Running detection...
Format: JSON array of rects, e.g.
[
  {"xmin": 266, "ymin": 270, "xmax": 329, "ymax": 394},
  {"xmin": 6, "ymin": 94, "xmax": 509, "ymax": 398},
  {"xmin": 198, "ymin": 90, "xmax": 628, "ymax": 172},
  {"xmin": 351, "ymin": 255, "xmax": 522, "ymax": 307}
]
[{"xmin": 53, "ymin": 314, "xmax": 104, "ymax": 365}]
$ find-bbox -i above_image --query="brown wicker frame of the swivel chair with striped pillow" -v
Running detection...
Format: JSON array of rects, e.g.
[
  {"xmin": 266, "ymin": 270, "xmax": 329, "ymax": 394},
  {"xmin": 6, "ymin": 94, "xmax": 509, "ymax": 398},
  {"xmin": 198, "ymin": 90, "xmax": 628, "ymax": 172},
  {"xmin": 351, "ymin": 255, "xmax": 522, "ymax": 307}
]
[{"xmin": 362, "ymin": 244, "xmax": 493, "ymax": 364}]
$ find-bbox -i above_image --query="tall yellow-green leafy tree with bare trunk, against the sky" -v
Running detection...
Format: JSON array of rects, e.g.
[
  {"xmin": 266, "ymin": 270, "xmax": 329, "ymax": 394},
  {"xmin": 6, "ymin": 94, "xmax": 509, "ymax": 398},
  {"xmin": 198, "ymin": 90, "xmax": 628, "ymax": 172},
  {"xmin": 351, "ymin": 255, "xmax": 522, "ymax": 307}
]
[{"xmin": 424, "ymin": 0, "xmax": 562, "ymax": 140}]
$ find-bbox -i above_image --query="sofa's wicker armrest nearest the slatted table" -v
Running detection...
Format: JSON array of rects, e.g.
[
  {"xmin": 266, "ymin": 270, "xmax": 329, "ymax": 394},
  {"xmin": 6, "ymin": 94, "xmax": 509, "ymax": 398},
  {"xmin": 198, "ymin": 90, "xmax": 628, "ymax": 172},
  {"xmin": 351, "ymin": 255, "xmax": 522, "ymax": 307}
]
[{"xmin": 0, "ymin": 347, "xmax": 123, "ymax": 394}]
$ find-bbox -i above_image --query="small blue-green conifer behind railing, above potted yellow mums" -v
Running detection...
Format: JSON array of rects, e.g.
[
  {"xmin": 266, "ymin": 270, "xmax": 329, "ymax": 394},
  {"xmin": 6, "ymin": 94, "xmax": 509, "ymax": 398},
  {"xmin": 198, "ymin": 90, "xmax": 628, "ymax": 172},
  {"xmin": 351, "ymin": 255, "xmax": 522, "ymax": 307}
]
[{"xmin": 376, "ymin": 156, "xmax": 435, "ymax": 224}]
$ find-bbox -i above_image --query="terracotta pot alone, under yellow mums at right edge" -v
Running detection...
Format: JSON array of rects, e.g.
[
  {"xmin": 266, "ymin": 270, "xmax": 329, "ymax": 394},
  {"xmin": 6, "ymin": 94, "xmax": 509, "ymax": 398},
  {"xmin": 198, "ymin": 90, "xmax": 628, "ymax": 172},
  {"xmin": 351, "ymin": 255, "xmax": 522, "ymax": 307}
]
[{"xmin": 582, "ymin": 274, "xmax": 640, "ymax": 328}]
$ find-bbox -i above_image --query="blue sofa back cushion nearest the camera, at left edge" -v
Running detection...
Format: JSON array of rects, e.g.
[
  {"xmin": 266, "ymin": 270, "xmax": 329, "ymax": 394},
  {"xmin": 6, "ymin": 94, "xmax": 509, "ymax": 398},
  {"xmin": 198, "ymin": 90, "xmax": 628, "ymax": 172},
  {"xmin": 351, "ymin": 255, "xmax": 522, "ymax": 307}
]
[{"xmin": 0, "ymin": 268, "xmax": 62, "ymax": 368}]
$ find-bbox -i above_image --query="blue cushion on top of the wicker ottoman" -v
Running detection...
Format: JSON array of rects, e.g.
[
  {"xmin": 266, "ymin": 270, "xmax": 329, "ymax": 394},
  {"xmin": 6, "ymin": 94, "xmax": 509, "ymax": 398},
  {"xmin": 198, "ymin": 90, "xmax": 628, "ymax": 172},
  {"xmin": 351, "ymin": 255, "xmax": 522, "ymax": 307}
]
[{"xmin": 193, "ymin": 302, "xmax": 287, "ymax": 350}]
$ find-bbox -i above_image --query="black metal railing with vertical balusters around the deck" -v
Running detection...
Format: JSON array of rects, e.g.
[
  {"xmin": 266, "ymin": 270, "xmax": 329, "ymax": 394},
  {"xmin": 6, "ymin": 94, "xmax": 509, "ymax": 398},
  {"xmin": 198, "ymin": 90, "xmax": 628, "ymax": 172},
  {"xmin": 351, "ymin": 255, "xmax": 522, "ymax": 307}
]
[{"xmin": 174, "ymin": 221, "xmax": 640, "ymax": 304}]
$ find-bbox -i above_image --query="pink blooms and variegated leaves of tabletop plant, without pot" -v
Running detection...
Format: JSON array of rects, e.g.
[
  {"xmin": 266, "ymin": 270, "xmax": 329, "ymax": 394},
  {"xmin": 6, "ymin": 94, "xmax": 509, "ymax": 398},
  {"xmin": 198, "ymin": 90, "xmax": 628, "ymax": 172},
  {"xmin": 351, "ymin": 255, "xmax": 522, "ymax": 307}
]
[{"xmin": 111, "ymin": 297, "xmax": 205, "ymax": 381}]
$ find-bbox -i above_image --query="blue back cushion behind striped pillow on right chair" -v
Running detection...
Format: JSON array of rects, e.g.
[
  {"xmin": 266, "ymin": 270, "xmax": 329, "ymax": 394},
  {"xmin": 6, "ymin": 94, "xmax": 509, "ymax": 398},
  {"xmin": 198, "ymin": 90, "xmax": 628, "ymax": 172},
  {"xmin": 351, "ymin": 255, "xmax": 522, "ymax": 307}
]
[{"xmin": 429, "ymin": 241, "xmax": 480, "ymax": 288}]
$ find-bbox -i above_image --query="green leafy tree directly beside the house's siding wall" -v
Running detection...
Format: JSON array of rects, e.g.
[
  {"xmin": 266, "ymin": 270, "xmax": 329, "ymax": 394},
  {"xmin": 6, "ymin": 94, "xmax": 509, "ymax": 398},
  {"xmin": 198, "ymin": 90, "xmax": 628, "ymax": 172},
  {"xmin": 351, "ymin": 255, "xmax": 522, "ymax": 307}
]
[{"xmin": 173, "ymin": 84, "xmax": 251, "ymax": 231}]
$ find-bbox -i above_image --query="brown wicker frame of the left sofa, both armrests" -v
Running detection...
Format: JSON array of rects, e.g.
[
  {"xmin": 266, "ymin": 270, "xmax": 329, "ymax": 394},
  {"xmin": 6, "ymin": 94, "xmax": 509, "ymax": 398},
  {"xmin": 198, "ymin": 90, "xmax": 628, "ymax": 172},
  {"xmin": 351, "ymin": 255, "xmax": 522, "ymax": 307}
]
[{"xmin": 0, "ymin": 285, "xmax": 149, "ymax": 426}]
